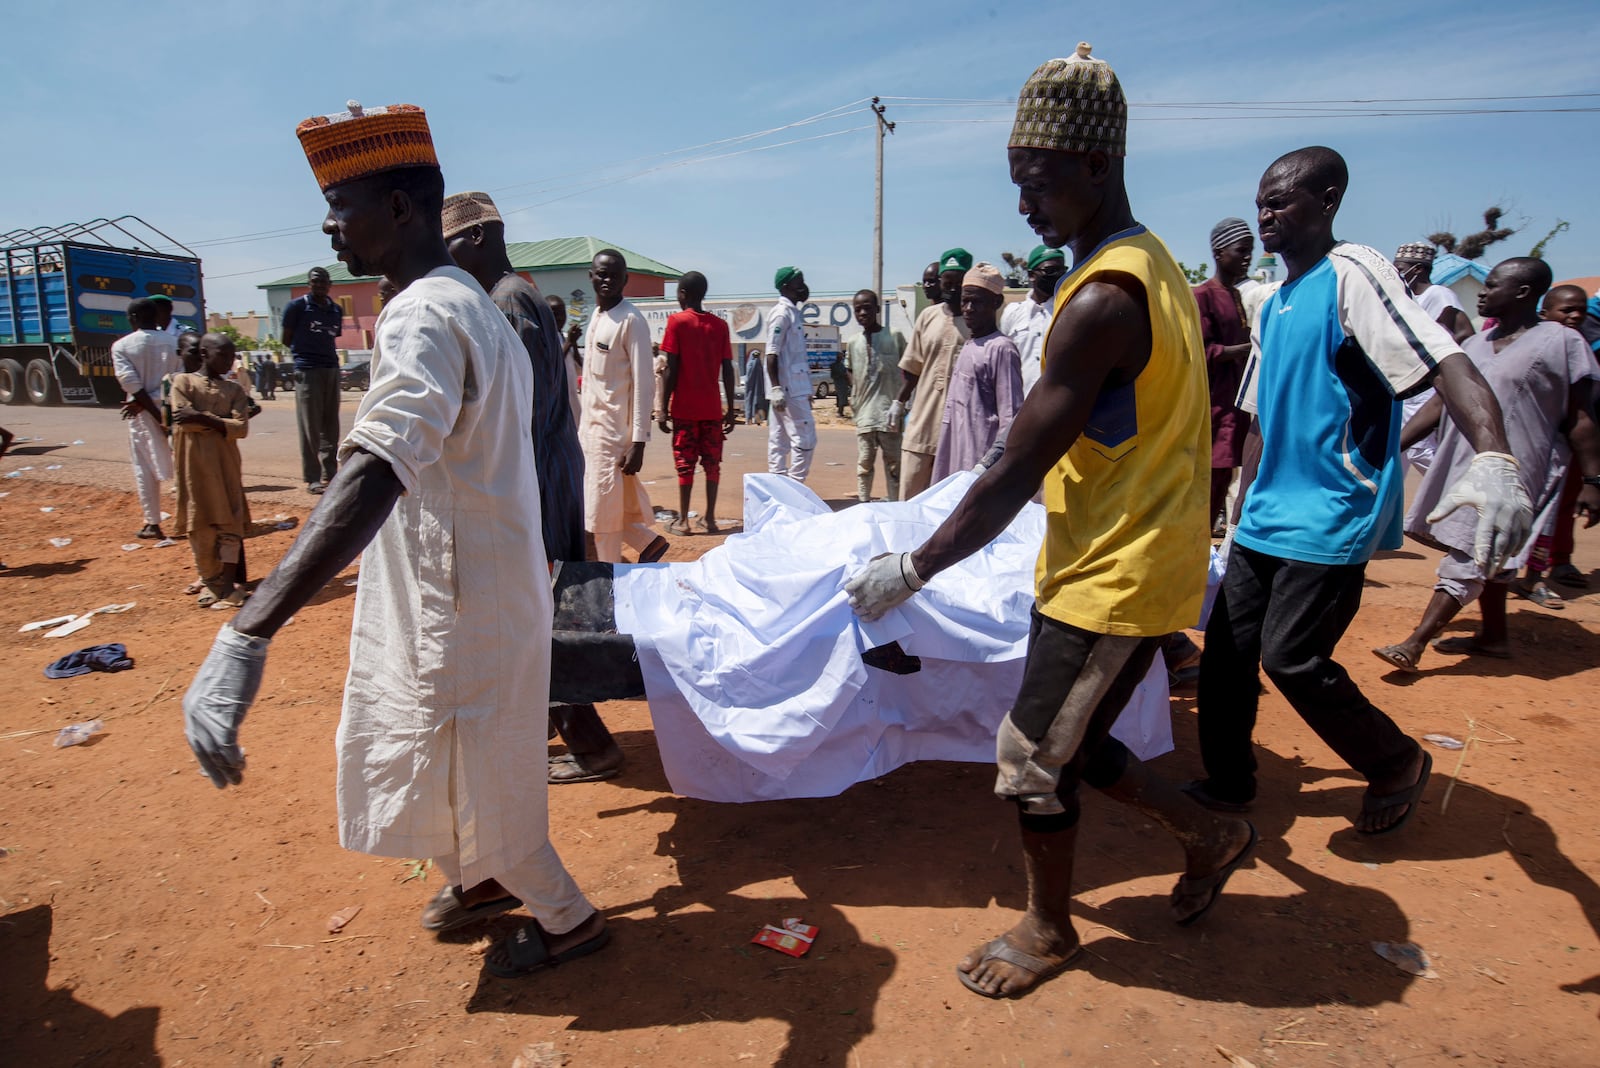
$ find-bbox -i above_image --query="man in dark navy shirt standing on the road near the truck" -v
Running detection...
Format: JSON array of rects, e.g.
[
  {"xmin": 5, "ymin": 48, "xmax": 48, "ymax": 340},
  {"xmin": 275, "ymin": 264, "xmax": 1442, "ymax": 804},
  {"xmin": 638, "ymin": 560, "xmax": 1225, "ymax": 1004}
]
[{"xmin": 278, "ymin": 267, "xmax": 344, "ymax": 494}]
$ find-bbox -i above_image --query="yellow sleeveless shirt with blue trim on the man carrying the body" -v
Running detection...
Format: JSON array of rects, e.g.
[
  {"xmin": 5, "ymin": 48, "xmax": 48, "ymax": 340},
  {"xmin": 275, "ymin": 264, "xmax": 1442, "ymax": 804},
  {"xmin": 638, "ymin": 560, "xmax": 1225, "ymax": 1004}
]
[{"xmin": 1035, "ymin": 227, "xmax": 1211, "ymax": 636}]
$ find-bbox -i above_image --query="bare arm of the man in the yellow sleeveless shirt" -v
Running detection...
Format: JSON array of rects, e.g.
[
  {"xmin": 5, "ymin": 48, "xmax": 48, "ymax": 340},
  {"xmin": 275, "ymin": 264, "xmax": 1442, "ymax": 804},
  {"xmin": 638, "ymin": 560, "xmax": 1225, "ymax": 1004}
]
[{"xmin": 910, "ymin": 275, "xmax": 1150, "ymax": 580}]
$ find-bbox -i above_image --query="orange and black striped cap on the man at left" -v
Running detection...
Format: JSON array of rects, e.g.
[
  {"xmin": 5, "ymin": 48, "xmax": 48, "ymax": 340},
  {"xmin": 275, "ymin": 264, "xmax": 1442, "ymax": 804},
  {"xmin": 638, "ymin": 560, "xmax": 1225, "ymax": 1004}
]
[{"xmin": 294, "ymin": 101, "xmax": 438, "ymax": 190}]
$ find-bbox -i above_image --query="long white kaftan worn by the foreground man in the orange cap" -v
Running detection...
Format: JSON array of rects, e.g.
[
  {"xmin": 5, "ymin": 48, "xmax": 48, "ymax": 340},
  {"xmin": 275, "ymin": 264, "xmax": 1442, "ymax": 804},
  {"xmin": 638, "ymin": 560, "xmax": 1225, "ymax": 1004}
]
[{"xmin": 338, "ymin": 267, "xmax": 576, "ymax": 897}]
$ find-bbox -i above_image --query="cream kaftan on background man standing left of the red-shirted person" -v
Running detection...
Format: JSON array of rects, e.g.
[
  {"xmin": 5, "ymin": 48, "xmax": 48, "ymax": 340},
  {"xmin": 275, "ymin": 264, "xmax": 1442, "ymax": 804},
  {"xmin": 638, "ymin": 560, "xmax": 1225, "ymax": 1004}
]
[{"xmin": 578, "ymin": 301, "xmax": 656, "ymax": 563}]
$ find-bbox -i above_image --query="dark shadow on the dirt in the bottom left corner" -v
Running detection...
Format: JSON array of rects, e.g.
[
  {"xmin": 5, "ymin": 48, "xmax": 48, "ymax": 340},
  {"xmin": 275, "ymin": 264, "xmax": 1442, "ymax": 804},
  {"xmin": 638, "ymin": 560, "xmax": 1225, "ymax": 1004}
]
[{"xmin": 0, "ymin": 905, "xmax": 162, "ymax": 1066}]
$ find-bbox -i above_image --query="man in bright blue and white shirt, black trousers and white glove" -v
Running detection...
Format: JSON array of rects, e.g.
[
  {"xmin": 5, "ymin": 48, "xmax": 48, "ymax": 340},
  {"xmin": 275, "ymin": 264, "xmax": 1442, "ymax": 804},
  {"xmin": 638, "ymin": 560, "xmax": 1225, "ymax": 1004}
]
[{"xmin": 1187, "ymin": 147, "xmax": 1533, "ymax": 835}]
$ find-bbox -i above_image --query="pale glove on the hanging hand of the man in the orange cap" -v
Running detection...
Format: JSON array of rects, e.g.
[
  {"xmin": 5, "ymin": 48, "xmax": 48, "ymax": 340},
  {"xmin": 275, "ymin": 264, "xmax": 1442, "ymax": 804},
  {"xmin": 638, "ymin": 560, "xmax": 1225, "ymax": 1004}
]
[{"xmin": 184, "ymin": 625, "xmax": 272, "ymax": 790}]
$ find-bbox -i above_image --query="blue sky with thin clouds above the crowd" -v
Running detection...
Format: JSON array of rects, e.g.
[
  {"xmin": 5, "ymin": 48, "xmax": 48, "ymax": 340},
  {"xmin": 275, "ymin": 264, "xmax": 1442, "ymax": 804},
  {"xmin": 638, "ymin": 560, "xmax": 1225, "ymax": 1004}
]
[{"xmin": 0, "ymin": 0, "xmax": 1600, "ymax": 312}]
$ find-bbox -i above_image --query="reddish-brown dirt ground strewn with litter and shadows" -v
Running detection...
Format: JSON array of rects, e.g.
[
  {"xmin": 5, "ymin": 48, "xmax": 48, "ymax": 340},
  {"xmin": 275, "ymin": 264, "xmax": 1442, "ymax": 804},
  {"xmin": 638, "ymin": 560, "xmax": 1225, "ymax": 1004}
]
[{"xmin": 0, "ymin": 428, "xmax": 1600, "ymax": 1068}]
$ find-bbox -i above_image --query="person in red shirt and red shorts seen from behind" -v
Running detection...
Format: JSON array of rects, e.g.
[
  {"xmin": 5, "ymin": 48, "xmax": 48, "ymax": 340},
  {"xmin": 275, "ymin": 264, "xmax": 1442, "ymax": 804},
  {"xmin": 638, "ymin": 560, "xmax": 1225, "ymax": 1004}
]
[{"xmin": 658, "ymin": 270, "xmax": 736, "ymax": 534}]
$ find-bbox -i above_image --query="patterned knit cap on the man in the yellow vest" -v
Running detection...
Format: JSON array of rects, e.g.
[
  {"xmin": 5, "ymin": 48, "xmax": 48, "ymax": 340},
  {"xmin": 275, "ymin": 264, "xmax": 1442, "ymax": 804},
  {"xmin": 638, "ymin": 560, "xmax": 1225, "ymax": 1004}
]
[{"xmin": 1006, "ymin": 42, "xmax": 1128, "ymax": 155}]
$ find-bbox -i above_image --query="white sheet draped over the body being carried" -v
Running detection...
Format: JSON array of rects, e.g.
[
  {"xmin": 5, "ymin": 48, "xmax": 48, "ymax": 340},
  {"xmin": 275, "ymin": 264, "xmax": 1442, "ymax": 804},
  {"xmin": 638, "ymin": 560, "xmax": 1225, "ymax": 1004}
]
[{"xmin": 616, "ymin": 472, "xmax": 1173, "ymax": 801}]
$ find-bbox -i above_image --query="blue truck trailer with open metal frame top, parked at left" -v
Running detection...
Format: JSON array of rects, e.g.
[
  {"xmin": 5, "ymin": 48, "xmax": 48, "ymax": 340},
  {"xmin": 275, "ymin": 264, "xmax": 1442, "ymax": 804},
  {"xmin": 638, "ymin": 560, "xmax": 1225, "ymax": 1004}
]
[{"xmin": 0, "ymin": 216, "xmax": 205, "ymax": 404}]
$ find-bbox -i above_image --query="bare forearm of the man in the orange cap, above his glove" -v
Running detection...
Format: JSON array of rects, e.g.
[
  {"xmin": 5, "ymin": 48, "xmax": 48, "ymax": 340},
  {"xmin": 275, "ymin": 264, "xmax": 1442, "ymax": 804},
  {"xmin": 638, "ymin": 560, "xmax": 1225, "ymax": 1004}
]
[{"xmin": 234, "ymin": 451, "xmax": 402, "ymax": 638}]
